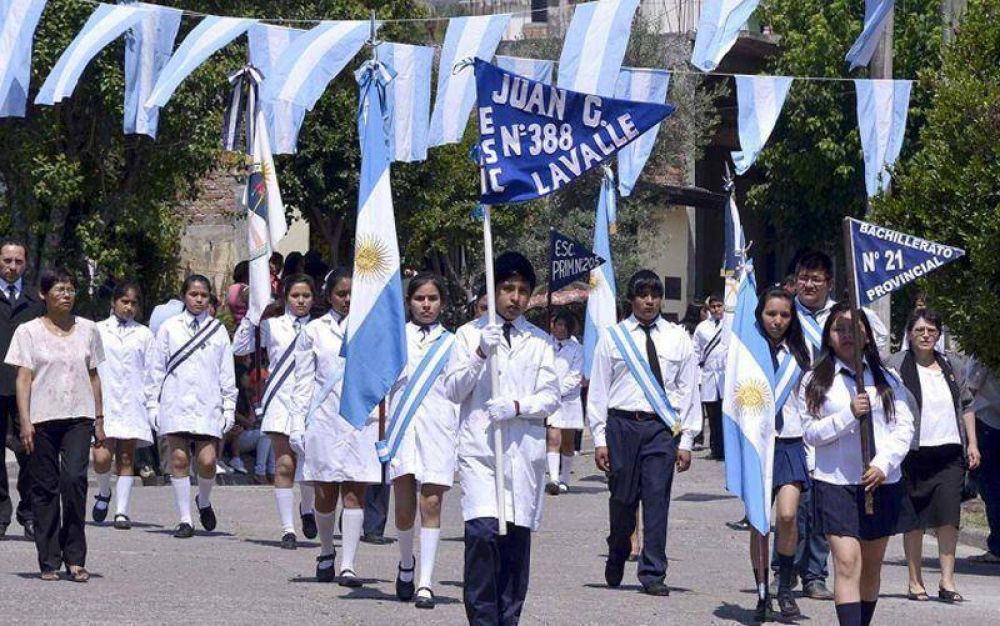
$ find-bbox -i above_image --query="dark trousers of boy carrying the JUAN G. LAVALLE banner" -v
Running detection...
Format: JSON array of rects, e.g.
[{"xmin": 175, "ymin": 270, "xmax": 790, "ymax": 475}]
[{"xmin": 462, "ymin": 517, "xmax": 531, "ymax": 626}]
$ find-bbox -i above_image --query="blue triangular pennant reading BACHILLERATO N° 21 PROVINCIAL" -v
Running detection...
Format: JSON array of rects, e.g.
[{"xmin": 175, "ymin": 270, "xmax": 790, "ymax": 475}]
[{"xmin": 847, "ymin": 218, "xmax": 965, "ymax": 306}]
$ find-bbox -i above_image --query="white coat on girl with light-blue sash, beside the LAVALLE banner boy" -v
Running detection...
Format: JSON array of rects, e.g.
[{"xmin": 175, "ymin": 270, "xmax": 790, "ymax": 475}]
[{"xmin": 389, "ymin": 322, "xmax": 458, "ymax": 487}]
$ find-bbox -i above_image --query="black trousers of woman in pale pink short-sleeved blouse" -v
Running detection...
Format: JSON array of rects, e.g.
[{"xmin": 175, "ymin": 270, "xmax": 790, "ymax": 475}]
[{"xmin": 28, "ymin": 419, "xmax": 94, "ymax": 572}]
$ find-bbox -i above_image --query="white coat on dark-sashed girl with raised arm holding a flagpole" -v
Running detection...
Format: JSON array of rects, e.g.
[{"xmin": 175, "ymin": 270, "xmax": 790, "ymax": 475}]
[{"xmin": 233, "ymin": 311, "xmax": 309, "ymax": 435}]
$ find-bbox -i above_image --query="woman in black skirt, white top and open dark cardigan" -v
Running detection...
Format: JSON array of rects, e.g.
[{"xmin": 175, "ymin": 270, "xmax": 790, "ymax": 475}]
[{"xmin": 890, "ymin": 309, "xmax": 979, "ymax": 603}]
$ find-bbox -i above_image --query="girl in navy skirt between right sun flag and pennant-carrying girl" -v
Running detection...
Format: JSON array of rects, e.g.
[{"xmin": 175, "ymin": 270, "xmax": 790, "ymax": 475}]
[{"xmin": 750, "ymin": 286, "xmax": 812, "ymax": 622}]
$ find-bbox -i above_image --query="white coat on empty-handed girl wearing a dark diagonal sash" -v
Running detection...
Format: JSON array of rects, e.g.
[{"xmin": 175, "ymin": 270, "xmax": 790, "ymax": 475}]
[{"xmin": 146, "ymin": 311, "xmax": 236, "ymax": 438}]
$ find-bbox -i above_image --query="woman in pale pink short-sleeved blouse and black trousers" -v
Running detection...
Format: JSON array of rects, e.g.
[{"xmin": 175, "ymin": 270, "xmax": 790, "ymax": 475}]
[{"xmin": 5, "ymin": 270, "xmax": 104, "ymax": 582}]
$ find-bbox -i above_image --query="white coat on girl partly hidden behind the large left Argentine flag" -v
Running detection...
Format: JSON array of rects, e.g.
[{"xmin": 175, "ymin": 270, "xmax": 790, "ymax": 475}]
[{"xmin": 291, "ymin": 311, "xmax": 382, "ymax": 483}]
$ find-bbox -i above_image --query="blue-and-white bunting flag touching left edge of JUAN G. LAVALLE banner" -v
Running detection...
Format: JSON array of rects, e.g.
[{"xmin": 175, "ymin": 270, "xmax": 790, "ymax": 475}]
[{"xmin": 428, "ymin": 13, "xmax": 510, "ymax": 147}]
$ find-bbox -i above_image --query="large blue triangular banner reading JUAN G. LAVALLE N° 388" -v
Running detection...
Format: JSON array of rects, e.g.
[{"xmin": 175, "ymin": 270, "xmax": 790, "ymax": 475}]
[{"xmin": 475, "ymin": 58, "xmax": 675, "ymax": 204}]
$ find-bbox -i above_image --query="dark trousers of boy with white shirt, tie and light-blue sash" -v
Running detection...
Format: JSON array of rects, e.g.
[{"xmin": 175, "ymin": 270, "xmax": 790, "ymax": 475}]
[{"xmin": 606, "ymin": 415, "xmax": 677, "ymax": 585}]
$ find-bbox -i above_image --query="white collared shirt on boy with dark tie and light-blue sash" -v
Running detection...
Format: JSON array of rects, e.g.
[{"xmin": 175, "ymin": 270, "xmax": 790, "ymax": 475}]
[{"xmin": 587, "ymin": 315, "xmax": 702, "ymax": 450}]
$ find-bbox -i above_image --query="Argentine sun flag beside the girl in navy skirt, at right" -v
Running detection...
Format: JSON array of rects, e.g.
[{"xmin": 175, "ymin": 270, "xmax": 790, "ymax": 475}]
[{"xmin": 722, "ymin": 263, "xmax": 775, "ymax": 534}]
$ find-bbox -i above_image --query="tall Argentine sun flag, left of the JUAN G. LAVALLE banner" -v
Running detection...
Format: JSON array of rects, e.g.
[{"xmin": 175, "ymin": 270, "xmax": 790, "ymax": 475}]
[{"xmin": 340, "ymin": 61, "xmax": 406, "ymax": 429}]
